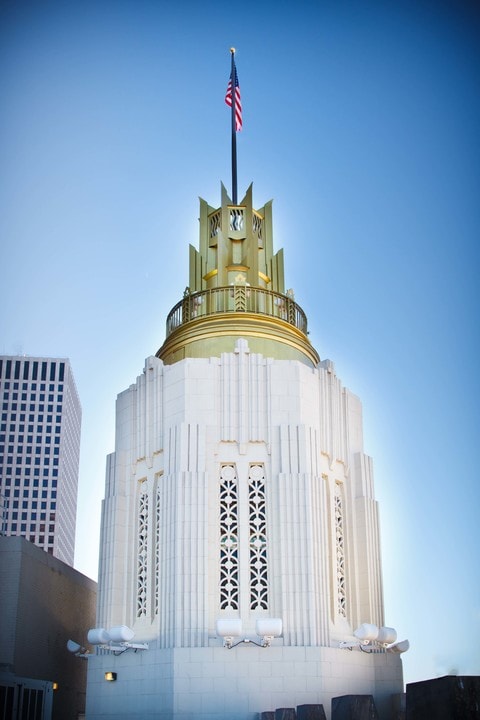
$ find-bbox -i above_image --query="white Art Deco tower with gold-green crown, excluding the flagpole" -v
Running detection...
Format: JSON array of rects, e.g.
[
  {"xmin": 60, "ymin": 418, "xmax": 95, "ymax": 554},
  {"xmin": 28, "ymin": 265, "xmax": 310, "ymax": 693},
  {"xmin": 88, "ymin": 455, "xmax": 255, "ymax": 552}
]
[{"xmin": 87, "ymin": 188, "xmax": 403, "ymax": 720}]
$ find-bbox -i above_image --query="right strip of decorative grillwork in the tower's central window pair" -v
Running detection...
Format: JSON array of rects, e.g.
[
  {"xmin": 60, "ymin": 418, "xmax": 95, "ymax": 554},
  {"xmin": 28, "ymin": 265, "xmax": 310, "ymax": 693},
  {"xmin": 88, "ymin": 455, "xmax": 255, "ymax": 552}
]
[{"xmin": 248, "ymin": 465, "xmax": 268, "ymax": 610}]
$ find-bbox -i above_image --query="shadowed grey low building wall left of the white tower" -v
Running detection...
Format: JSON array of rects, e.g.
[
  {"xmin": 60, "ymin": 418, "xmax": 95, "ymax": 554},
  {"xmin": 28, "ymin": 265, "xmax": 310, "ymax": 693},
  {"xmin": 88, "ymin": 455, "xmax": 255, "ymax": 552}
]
[{"xmin": 0, "ymin": 537, "xmax": 97, "ymax": 720}]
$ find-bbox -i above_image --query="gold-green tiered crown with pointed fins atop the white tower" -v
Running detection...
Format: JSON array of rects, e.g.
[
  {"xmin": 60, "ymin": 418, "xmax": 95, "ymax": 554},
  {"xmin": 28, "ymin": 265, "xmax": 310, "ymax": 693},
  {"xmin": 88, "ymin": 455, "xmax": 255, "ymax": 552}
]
[{"xmin": 157, "ymin": 185, "xmax": 320, "ymax": 367}]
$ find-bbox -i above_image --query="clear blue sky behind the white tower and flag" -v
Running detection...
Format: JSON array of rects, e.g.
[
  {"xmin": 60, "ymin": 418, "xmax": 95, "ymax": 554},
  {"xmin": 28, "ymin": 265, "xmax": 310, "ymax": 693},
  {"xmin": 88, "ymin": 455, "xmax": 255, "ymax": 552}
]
[{"xmin": 0, "ymin": 0, "xmax": 480, "ymax": 682}]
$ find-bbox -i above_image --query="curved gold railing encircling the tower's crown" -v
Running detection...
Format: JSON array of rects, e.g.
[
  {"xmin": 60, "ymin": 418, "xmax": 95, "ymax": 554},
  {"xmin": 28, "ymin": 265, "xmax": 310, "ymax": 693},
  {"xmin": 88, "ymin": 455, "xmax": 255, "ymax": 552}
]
[{"xmin": 167, "ymin": 285, "xmax": 307, "ymax": 337}]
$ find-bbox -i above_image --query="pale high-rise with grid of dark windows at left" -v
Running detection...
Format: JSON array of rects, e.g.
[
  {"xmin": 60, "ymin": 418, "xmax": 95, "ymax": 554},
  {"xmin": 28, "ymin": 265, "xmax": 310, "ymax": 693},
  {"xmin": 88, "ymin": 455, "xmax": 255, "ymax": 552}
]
[{"xmin": 0, "ymin": 355, "xmax": 82, "ymax": 565}]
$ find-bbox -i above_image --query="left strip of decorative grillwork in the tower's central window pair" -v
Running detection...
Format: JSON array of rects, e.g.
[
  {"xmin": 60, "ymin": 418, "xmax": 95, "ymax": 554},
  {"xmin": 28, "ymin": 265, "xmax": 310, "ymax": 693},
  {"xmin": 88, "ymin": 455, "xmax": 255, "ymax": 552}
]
[{"xmin": 220, "ymin": 465, "xmax": 239, "ymax": 610}]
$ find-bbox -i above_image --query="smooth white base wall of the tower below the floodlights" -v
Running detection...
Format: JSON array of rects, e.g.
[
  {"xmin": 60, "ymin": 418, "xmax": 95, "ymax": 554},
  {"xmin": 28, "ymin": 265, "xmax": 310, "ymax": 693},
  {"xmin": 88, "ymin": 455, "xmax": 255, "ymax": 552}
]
[{"xmin": 87, "ymin": 644, "xmax": 403, "ymax": 720}]
